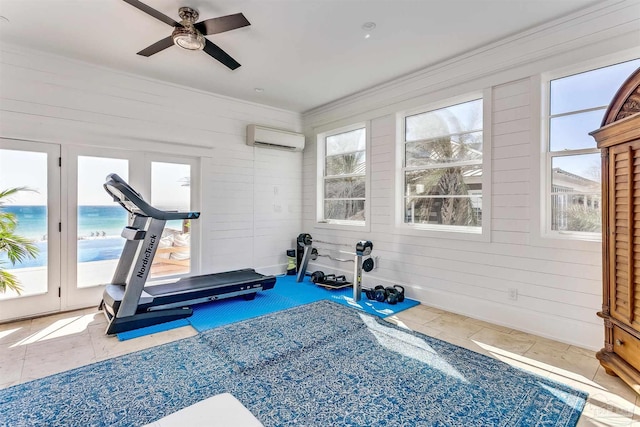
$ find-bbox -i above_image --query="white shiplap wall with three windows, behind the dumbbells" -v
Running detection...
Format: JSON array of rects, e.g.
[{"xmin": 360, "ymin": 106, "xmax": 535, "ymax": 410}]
[{"xmin": 303, "ymin": 1, "xmax": 640, "ymax": 350}]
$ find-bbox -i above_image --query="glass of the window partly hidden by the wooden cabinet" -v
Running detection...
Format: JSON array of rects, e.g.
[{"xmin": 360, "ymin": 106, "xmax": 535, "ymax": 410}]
[{"xmin": 546, "ymin": 60, "xmax": 640, "ymax": 238}]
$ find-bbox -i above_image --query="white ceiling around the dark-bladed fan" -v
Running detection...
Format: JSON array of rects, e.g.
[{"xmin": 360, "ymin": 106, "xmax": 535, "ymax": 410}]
[{"xmin": 0, "ymin": 0, "xmax": 598, "ymax": 112}]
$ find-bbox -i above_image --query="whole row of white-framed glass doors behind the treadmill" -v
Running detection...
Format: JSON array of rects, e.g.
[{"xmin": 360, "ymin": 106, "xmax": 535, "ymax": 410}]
[{"xmin": 0, "ymin": 139, "xmax": 199, "ymax": 321}]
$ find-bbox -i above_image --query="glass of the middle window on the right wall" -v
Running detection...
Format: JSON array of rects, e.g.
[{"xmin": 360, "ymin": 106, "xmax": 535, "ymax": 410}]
[{"xmin": 402, "ymin": 99, "xmax": 483, "ymax": 232}]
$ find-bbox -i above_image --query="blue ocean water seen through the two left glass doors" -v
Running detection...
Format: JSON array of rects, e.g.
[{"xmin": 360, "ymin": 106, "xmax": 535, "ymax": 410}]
[{"xmin": 0, "ymin": 205, "xmax": 128, "ymax": 268}]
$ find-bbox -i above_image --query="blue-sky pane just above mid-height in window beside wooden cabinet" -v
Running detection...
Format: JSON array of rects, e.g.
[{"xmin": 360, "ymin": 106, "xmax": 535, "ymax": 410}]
[{"xmin": 549, "ymin": 109, "xmax": 605, "ymax": 151}]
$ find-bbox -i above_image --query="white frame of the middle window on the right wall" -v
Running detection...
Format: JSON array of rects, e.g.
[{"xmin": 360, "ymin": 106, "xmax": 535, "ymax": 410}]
[{"xmin": 394, "ymin": 88, "xmax": 492, "ymax": 241}]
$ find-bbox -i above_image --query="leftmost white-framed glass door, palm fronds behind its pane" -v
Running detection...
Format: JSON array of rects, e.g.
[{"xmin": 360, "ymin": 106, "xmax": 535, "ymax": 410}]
[{"xmin": 0, "ymin": 139, "xmax": 60, "ymax": 320}]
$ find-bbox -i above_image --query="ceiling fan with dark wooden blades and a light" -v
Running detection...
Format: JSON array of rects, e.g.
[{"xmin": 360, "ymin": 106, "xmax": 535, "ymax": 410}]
[{"xmin": 124, "ymin": 0, "xmax": 251, "ymax": 70}]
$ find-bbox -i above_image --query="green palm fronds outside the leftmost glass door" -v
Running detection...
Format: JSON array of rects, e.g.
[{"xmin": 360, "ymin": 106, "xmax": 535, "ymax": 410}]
[{"xmin": 0, "ymin": 187, "xmax": 38, "ymax": 295}]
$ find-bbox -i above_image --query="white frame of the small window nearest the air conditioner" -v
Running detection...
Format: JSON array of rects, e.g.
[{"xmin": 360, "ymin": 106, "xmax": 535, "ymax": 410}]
[{"xmin": 316, "ymin": 121, "xmax": 371, "ymax": 231}]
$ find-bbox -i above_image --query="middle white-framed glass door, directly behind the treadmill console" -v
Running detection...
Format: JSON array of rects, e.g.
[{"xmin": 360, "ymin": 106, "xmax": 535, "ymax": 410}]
[{"xmin": 62, "ymin": 147, "xmax": 135, "ymax": 308}]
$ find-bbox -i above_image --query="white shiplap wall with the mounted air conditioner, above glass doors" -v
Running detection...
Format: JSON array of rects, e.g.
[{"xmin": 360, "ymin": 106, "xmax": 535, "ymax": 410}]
[{"xmin": 0, "ymin": 46, "xmax": 302, "ymax": 290}]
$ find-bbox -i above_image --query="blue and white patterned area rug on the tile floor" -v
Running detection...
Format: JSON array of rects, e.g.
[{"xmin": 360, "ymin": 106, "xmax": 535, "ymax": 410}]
[{"xmin": 0, "ymin": 301, "xmax": 586, "ymax": 427}]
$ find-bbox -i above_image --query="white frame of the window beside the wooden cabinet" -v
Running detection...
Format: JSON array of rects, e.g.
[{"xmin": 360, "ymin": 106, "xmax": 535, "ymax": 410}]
[{"xmin": 531, "ymin": 53, "xmax": 637, "ymax": 244}]
